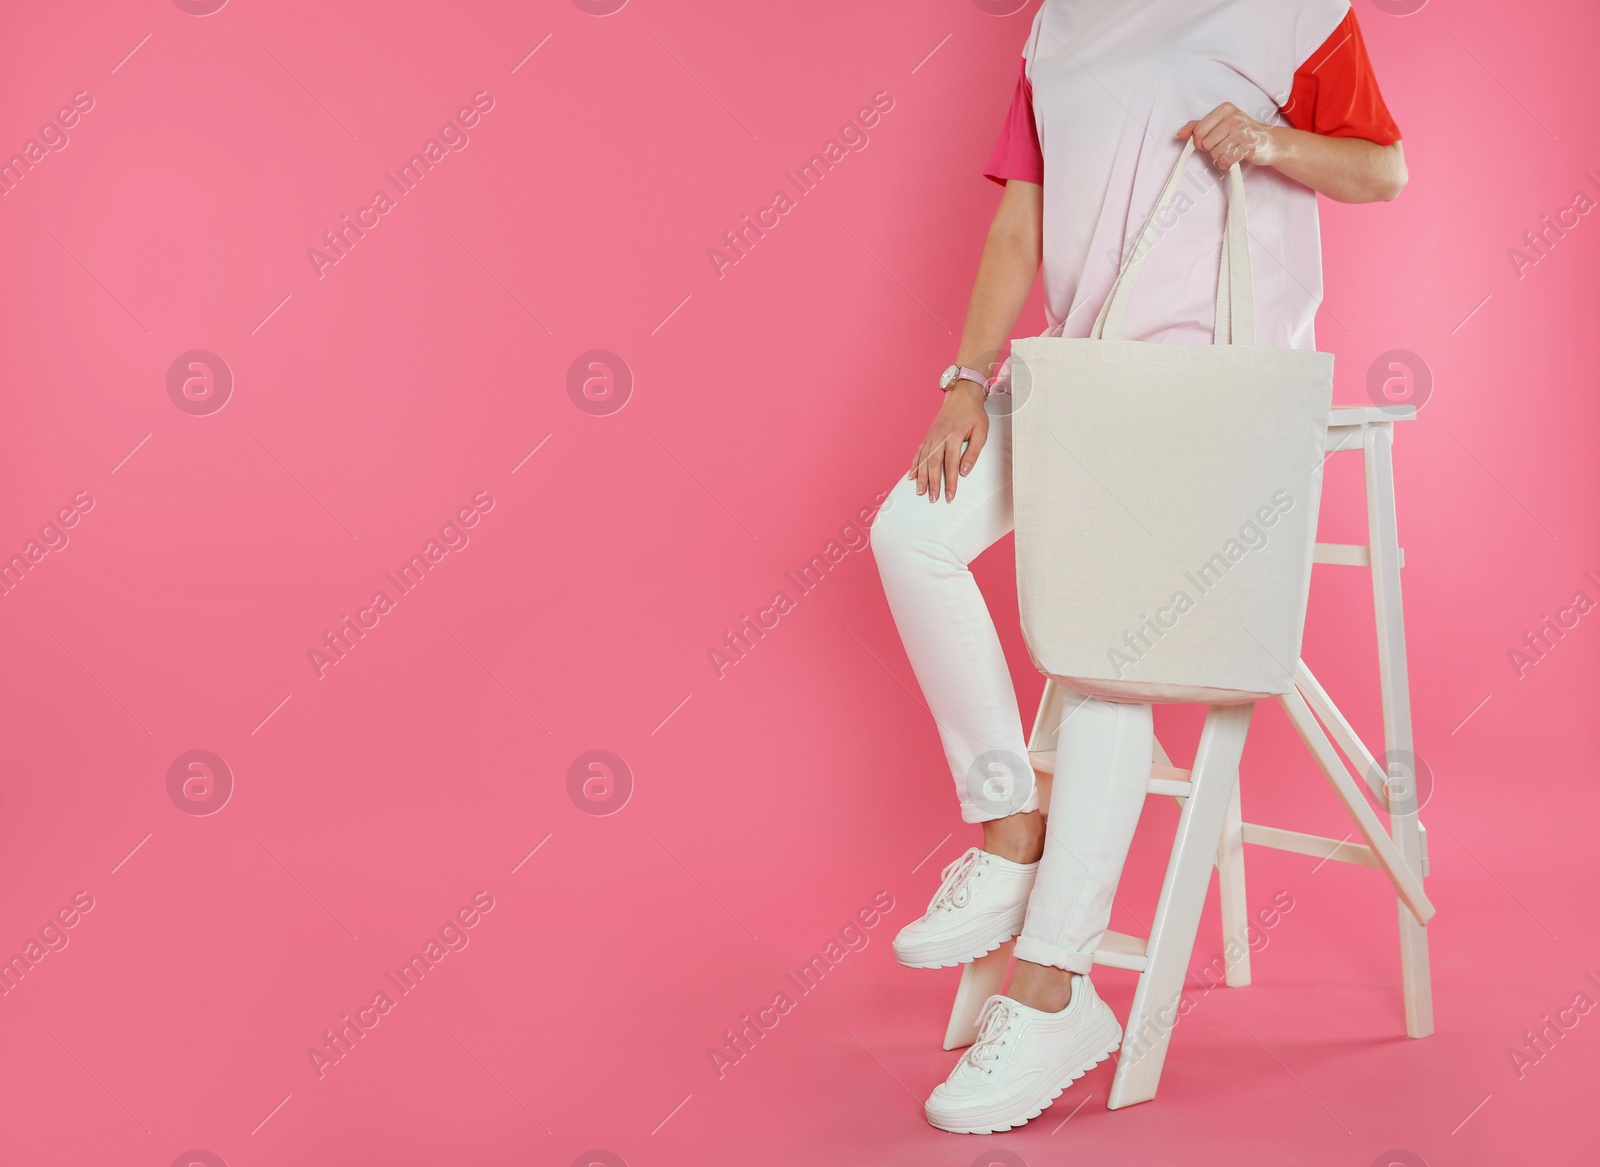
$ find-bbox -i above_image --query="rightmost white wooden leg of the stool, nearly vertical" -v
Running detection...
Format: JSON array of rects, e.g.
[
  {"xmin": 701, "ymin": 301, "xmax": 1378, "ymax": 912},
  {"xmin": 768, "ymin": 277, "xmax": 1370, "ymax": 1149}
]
[{"xmin": 1362, "ymin": 426, "xmax": 1434, "ymax": 1037}]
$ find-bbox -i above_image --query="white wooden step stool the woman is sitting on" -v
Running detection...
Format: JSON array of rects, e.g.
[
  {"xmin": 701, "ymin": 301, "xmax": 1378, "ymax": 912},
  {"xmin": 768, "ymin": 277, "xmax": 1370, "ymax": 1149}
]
[{"xmin": 944, "ymin": 407, "xmax": 1434, "ymax": 1109}]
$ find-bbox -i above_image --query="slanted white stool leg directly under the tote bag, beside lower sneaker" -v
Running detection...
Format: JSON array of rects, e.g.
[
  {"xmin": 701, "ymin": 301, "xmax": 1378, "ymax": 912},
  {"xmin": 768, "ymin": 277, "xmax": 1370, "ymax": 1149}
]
[{"xmin": 1106, "ymin": 704, "xmax": 1254, "ymax": 1109}]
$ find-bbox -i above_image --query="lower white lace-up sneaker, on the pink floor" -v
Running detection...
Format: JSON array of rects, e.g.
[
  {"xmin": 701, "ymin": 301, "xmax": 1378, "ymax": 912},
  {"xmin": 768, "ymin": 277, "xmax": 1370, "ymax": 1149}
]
[{"xmin": 923, "ymin": 977, "xmax": 1122, "ymax": 1135}]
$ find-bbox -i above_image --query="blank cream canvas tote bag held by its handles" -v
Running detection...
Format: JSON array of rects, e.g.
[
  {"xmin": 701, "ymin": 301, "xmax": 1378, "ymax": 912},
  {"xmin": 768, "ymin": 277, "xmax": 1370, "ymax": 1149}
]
[{"xmin": 1011, "ymin": 138, "xmax": 1333, "ymax": 704}]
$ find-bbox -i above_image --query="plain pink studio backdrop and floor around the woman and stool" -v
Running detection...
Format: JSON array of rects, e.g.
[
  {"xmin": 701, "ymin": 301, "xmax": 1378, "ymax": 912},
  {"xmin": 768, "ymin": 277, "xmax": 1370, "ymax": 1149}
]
[{"xmin": 0, "ymin": 0, "xmax": 1600, "ymax": 1167}]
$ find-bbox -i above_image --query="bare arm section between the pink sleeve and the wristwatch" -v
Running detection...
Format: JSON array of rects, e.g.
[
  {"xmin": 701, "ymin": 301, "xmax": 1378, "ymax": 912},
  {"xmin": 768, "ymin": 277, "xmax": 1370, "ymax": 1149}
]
[{"xmin": 955, "ymin": 179, "xmax": 1043, "ymax": 375}]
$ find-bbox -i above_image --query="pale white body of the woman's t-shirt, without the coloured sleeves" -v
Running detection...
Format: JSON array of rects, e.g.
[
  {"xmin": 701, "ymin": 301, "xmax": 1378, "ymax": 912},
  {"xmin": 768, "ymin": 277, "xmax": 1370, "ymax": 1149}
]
[{"xmin": 1003, "ymin": 0, "xmax": 1350, "ymax": 392}]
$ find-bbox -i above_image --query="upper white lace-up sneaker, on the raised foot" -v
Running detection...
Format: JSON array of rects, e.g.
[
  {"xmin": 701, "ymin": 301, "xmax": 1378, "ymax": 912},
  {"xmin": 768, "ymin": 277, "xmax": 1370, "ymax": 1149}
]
[{"xmin": 894, "ymin": 847, "xmax": 1038, "ymax": 968}]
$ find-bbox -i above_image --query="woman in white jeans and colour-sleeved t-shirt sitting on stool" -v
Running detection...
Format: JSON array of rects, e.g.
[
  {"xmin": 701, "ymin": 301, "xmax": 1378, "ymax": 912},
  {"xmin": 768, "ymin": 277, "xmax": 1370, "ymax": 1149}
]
[{"xmin": 872, "ymin": 0, "xmax": 1406, "ymax": 1133}]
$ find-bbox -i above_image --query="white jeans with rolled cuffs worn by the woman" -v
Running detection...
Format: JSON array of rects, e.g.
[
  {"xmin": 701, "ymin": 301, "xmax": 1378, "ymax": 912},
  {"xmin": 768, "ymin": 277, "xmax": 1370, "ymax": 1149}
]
[{"xmin": 872, "ymin": 395, "xmax": 1155, "ymax": 973}]
